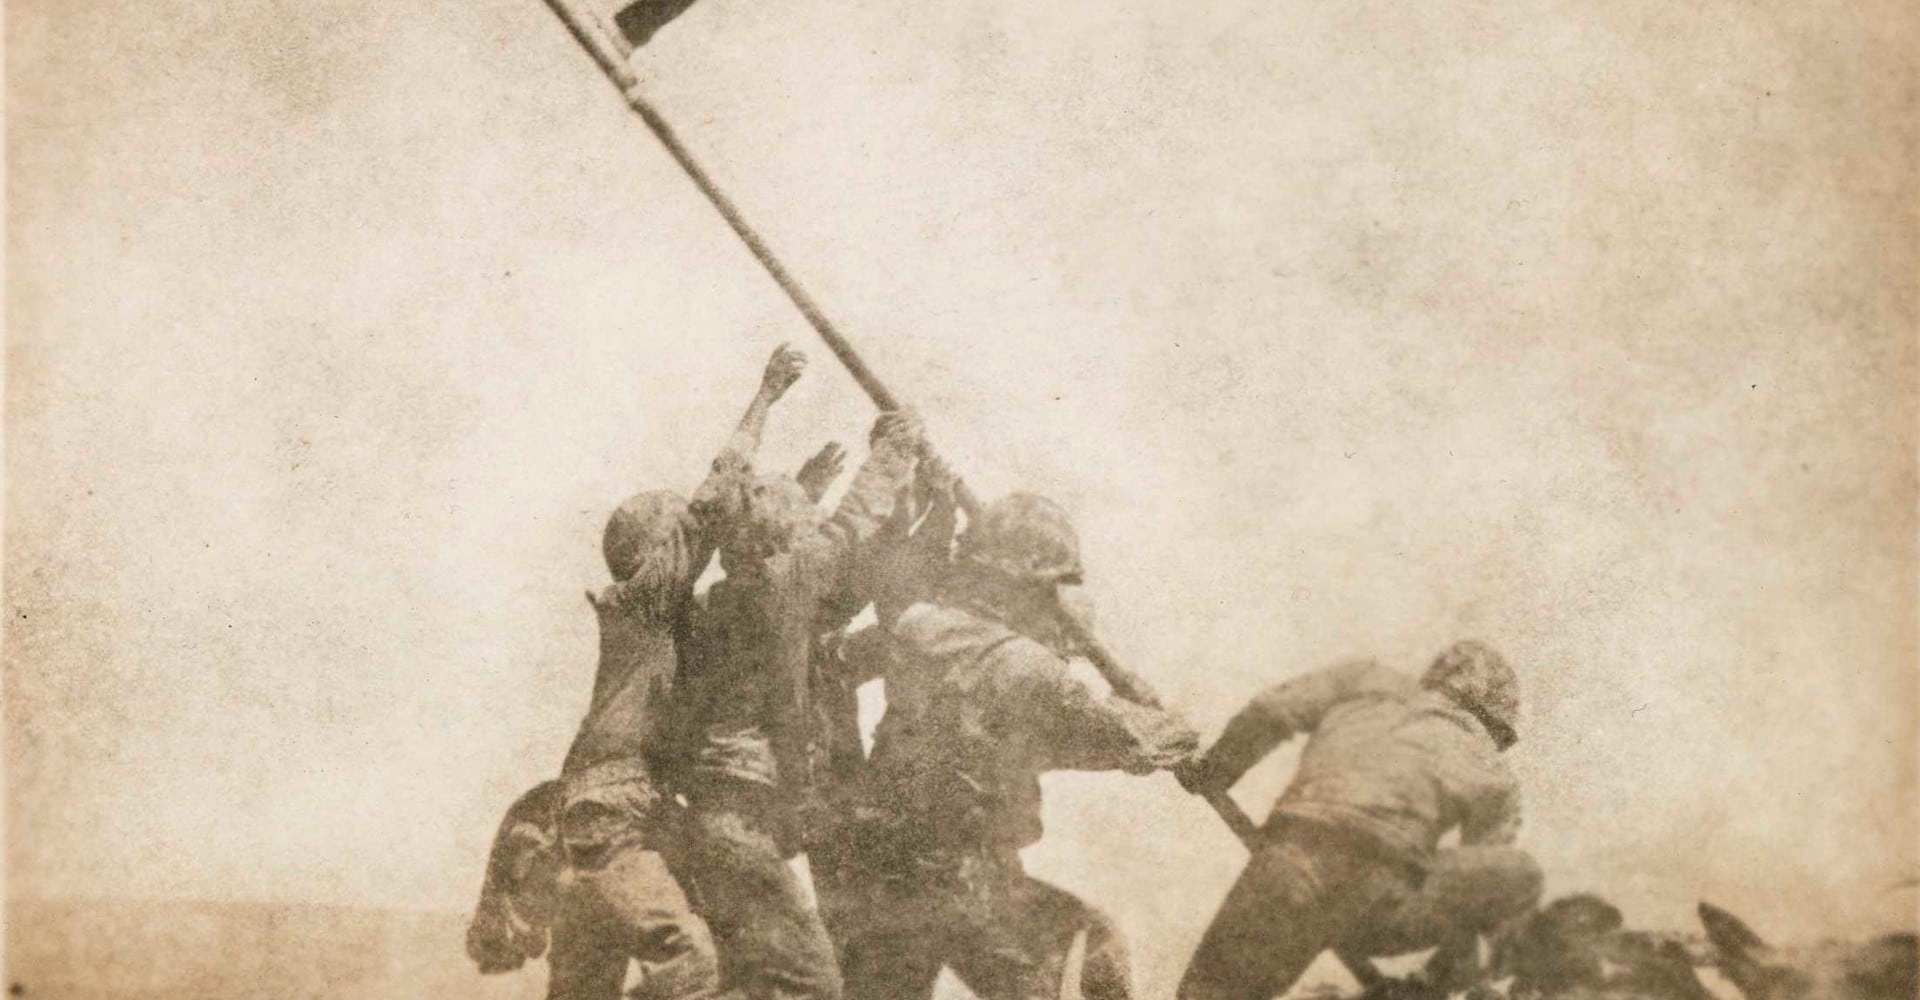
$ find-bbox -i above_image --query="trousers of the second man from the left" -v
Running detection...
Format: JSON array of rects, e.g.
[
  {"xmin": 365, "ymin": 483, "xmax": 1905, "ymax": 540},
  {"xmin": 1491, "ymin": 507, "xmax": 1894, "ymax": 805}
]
[{"xmin": 687, "ymin": 785, "xmax": 841, "ymax": 1000}]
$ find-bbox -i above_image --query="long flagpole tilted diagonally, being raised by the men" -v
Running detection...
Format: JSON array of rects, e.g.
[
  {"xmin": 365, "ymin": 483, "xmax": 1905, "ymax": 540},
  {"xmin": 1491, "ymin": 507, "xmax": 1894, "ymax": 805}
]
[{"xmin": 547, "ymin": 0, "xmax": 1260, "ymax": 848}]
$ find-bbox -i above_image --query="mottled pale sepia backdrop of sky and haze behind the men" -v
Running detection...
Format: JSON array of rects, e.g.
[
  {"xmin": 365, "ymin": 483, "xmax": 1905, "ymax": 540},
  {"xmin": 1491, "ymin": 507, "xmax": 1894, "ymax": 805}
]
[{"xmin": 4, "ymin": 0, "xmax": 1920, "ymax": 996}]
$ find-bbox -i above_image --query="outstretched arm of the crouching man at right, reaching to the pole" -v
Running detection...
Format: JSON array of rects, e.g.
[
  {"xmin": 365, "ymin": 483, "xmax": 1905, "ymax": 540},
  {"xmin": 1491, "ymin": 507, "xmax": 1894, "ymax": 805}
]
[{"xmin": 1179, "ymin": 660, "xmax": 1405, "ymax": 793}]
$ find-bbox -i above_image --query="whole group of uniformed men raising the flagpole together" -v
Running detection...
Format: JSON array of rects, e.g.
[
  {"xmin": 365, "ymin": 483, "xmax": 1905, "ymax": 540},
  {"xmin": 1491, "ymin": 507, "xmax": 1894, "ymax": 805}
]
[{"xmin": 467, "ymin": 347, "xmax": 1540, "ymax": 1000}]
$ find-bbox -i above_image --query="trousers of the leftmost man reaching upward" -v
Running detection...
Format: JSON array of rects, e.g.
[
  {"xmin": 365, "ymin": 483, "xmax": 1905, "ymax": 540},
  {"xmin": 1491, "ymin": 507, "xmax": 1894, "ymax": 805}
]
[{"xmin": 547, "ymin": 804, "xmax": 720, "ymax": 1000}]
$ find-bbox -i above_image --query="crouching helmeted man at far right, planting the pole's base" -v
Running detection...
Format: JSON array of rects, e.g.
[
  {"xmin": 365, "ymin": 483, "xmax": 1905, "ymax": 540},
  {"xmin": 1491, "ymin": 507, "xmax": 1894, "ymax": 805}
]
[{"xmin": 1177, "ymin": 641, "xmax": 1542, "ymax": 1000}]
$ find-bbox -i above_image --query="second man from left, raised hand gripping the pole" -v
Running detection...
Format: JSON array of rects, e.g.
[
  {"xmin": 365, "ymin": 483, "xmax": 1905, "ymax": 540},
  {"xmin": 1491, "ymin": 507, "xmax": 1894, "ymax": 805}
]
[{"xmin": 685, "ymin": 413, "xmax": 924, "ymax": 1000}]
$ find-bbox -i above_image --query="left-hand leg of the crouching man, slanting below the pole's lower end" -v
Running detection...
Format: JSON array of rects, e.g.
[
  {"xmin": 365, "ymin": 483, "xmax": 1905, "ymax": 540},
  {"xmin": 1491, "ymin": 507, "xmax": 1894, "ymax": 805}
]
[{"xmin": 1179, "ymin": 831, "xmax": 1405, "ymax": 1000}]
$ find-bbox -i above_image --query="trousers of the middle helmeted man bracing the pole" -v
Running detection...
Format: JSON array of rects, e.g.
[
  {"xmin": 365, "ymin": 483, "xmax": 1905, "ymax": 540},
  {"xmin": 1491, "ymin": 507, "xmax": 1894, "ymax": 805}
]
[{"xmin": 841, "ymin": 850, "xmax": 1133, "ymax": 1000}]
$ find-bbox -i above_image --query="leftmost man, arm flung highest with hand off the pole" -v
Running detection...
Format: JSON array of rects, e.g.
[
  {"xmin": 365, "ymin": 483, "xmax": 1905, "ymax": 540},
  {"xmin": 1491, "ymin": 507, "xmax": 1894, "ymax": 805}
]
[{"xmin": 468, "ymin": 345, "xmax": 817, "ymax": 1000}]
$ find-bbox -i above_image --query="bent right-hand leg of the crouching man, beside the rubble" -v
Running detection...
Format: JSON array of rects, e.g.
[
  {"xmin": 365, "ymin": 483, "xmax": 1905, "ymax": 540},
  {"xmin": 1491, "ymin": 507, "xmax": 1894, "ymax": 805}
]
[{"xmin": 1340, "ymin": 846, "xmax": 1544, "ymax": 988}]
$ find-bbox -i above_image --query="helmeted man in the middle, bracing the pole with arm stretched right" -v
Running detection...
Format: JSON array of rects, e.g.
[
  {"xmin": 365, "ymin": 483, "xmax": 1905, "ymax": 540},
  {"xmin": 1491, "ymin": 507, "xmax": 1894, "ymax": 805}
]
[{"xmin": 841, "ymin": 495, "xmax": 1196, "ymax": 1000}]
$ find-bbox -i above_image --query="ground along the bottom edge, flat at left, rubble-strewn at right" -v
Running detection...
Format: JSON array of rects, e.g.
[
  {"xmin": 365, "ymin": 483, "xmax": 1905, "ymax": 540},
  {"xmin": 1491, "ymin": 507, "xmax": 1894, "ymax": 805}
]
[{"xmin": 4, "ymin": 896, "xmax": 1920, "ymax": 1000}]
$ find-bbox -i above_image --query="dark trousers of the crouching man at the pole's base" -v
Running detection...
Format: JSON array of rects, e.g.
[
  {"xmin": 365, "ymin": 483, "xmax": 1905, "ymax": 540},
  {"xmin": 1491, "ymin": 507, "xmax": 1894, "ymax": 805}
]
[{"xmin": 1179, "ymin": 821, "xmax": 1540, "ymax": 1000}]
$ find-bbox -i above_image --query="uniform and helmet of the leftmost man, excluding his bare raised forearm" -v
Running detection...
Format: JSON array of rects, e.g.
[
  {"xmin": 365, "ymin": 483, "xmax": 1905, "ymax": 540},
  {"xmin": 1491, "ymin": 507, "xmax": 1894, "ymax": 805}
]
[{"xmin": 547, "ymin": 476, "xmax": 751, "ymax": 1000}]
